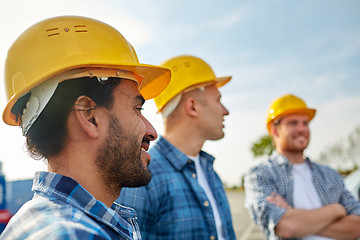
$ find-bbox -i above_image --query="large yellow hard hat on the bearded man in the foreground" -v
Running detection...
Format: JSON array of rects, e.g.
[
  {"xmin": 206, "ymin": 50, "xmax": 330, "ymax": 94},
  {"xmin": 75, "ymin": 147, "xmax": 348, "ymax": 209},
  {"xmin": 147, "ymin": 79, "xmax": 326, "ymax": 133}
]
[{"xmin": 3, "ymin": 16, "xmax": 171, "ymax": 125}]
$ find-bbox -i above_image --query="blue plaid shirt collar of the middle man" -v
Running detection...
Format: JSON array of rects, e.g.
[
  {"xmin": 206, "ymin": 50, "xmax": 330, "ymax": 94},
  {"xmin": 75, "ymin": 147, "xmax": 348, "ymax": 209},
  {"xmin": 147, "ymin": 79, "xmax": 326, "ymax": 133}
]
[{"xmin": 155, "ymin": 136, "xmax": 215, "ymax": 171}]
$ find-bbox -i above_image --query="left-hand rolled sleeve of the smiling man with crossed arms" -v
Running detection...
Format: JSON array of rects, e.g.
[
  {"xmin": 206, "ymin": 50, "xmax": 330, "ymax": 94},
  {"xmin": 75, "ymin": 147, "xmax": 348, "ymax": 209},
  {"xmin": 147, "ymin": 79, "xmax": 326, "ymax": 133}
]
[{"xmin": 244, "ymin": 166, "xmax": 286, "ymax": 232}]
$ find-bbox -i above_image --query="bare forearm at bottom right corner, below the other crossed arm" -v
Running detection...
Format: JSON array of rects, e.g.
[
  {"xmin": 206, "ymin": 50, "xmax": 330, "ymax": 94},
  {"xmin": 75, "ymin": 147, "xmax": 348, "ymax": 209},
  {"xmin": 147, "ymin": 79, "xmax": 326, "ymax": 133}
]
[{"xmin": 316, "ymin": 215, "xmax": 360, "ymax": 239}]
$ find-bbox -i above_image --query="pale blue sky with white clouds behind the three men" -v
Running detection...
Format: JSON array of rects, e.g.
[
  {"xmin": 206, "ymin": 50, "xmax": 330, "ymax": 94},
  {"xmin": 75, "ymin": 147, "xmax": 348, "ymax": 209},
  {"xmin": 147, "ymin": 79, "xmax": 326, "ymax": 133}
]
[{"xmin": 0, "ymin": 0, "xmax": 360, "ymax": 186}]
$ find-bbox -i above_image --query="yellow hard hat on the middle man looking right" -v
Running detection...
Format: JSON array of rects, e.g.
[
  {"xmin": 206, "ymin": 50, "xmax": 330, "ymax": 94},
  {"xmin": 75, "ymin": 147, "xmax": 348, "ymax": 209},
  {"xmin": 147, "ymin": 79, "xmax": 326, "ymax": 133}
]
[{"xmin": 154, "ymin": 55, "xmax": 231, "ymax": 112}]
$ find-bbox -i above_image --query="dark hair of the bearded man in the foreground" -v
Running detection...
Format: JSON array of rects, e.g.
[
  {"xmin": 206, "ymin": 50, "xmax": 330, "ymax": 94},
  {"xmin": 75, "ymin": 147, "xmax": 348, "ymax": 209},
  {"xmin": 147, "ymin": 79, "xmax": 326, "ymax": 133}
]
[{"xmin": 13, "ymin": 77, "xmax": 121, "ymax": 159}]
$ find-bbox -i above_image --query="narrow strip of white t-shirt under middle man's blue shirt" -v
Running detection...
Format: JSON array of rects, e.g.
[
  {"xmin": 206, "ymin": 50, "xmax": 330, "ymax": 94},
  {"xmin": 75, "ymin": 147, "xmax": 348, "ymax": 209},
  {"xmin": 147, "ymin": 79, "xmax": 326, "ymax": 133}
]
[{"xmin": 188, "ymin": 155, "xmax": 225, "ymax": 240}]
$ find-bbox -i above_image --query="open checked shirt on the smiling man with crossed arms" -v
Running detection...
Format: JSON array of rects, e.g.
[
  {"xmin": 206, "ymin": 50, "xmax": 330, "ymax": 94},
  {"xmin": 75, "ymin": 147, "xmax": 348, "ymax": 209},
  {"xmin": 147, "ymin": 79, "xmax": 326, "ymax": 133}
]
[{"xmin": 245, "ymin": 152, "xmax": 360, "ymax": 239}]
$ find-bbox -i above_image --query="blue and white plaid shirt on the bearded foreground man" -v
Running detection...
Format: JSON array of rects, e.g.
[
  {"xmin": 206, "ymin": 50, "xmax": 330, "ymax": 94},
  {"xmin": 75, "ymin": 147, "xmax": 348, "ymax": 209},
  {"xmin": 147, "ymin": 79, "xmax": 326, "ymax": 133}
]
[{"xmin": 0, "ymin": 172, "xmax": 141, "ymax": 239}]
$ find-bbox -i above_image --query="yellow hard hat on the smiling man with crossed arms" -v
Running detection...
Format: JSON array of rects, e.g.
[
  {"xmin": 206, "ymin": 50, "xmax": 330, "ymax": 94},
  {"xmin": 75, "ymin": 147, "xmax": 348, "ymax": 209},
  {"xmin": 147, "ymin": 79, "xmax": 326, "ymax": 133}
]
[{"xmin": 266, "ymin": 94, "xmax": 316, "ymax": 132}]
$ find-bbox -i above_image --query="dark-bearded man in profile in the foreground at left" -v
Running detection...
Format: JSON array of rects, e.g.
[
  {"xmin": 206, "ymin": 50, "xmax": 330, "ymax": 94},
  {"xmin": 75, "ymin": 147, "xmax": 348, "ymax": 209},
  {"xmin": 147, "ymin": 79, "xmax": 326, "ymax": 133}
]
[{"xmin": 1, "ymin": 16, "xmax": 170, "ymax": 239}]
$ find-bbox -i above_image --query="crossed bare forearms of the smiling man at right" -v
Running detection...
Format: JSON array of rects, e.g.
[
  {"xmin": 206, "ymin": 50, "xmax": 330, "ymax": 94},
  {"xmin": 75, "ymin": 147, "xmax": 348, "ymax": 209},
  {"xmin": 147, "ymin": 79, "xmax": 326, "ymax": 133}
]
[{"xmin": 267, "ymin": 194, "xmax": 360, "ymax": 239}]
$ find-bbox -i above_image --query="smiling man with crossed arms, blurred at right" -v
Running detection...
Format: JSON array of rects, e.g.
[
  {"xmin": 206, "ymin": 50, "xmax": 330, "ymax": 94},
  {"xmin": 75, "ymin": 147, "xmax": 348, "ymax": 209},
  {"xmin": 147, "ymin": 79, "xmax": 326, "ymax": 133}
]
[{"xmin": 245, "ymin": 94, "xmax": 360, "ymax": 240}]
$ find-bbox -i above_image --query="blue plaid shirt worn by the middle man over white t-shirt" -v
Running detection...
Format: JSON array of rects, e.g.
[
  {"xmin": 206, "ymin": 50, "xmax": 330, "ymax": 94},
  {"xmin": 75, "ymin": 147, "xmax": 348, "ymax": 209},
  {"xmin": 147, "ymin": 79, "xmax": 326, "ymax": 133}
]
[{"xmin": 117, "ymin": 137, "xmax": 235, "ymax": 240}]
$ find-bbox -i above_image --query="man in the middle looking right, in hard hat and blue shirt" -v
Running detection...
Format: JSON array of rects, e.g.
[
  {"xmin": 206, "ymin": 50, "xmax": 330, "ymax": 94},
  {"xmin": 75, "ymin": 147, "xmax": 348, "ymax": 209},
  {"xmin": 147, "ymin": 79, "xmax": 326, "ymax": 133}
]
[{"xmin": 118, "ymin": 55, "xmax": 235, "ymax": 240}]
